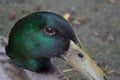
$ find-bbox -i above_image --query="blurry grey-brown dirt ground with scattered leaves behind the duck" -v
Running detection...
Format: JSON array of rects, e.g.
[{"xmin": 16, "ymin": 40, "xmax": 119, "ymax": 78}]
[{"xmin": 0, "ymin": 0, "xmax": 120, "ymax": 80}]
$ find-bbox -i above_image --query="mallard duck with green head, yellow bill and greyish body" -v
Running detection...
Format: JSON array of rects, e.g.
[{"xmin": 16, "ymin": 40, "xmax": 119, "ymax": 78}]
[{"xmin": 0, "ymin": 11, "xmax": 107, "ymax": 80}]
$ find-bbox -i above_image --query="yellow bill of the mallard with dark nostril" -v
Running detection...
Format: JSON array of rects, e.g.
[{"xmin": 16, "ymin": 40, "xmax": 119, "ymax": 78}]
[{"xmin": 62, "ymin": 41, "xmax": 107, "ymax": 80}]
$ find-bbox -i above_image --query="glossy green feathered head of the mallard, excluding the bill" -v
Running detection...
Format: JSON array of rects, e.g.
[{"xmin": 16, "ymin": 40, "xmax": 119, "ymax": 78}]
[{"xmin": 6, "ymin": 12, "xmax": 78, "ymax": 72}]
